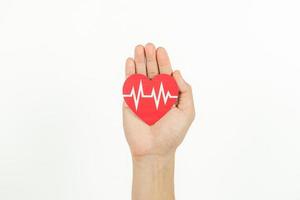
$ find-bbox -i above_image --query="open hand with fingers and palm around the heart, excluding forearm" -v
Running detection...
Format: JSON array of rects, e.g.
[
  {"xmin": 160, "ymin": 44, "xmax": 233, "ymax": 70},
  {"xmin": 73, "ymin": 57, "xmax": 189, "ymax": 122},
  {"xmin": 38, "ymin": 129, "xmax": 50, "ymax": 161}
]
[{"xmin": 123, "ymin": 43, "xmax": 195, "ymax": 158}]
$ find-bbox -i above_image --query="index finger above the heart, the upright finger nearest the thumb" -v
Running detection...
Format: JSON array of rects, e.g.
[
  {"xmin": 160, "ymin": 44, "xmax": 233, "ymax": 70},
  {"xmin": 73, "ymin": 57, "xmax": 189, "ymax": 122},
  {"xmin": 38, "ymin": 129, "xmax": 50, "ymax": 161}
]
[{"xmin": 156, "ymin": 47, "xmax": 172, "ymax": 75}]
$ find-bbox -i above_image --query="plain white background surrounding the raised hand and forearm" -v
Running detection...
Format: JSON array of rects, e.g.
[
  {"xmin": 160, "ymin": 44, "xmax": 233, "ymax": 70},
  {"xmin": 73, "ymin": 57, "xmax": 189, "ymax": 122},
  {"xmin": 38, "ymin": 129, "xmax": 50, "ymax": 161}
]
[{"xmin": 0, "ymin": 0, "xmax": 300, "ymax": 200}]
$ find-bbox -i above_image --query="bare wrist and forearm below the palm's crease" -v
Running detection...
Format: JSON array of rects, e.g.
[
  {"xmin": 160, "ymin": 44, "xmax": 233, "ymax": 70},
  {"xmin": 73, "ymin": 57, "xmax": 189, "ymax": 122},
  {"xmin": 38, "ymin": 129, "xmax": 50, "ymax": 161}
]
[{"xmin": 132, "ymin": 153, "xmax": 175, "ymax": 200}]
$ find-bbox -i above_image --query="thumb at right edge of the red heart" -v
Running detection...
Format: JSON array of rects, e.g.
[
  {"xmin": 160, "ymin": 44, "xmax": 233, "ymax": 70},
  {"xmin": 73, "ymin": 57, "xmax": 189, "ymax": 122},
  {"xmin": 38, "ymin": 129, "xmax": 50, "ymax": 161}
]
[{"xmin": 173, "ymin": 71, "xmax": 194, "ymax": 111}]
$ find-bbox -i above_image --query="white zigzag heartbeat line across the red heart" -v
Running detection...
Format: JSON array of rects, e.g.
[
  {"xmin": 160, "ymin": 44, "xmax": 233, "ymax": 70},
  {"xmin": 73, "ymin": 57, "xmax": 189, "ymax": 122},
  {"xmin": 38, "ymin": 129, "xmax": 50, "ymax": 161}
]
[{"xmin": 123, "ymin": 81, "xmax": 178, "ymax": 110}]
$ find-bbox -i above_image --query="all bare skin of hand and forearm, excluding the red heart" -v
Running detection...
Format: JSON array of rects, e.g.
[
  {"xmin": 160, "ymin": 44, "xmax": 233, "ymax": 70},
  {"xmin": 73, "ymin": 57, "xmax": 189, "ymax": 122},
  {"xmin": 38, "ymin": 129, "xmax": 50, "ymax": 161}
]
[{"xmin": 123, "ymin": 43, "xmax": 195, "ymax": 200}]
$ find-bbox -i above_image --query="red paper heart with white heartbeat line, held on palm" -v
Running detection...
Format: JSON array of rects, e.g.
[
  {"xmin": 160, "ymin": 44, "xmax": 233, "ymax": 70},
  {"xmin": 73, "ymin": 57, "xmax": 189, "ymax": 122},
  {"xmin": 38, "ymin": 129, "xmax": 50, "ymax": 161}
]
[{"xmin": 123, "ymin": 74, "xmax": 179, "ymax": 125}]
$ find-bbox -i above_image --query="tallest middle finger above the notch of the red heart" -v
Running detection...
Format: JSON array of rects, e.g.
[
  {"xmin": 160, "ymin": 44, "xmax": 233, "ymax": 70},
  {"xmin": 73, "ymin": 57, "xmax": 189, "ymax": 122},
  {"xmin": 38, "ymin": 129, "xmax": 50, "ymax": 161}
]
[{"xmin": 145, "ymin": 43, "xmax": 158, "ymax": 78}]
